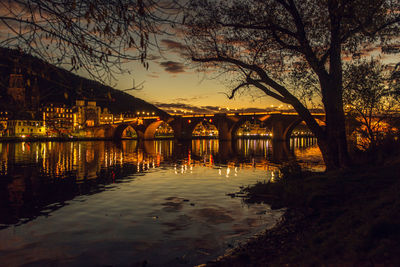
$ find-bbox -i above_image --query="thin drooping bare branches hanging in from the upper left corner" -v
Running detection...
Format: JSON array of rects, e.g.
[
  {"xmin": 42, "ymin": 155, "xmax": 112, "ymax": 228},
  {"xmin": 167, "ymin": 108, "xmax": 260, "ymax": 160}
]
[{"xmin": 0, "ymin": 0, "xmax": 178, "ymax": 81}]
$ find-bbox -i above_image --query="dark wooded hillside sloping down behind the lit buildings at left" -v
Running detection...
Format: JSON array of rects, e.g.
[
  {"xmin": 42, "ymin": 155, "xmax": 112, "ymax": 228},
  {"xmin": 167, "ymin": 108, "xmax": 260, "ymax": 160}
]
[{"xmin": 0, "ymin": 48, "xmax": 167, "ymax": 116}]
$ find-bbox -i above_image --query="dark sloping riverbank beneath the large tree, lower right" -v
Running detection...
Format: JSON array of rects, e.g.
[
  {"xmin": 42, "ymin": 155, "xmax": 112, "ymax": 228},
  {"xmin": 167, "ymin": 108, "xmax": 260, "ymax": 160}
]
[{"xmin": 206, "ymin": 159, "xmax": 400, "ymax": 266}]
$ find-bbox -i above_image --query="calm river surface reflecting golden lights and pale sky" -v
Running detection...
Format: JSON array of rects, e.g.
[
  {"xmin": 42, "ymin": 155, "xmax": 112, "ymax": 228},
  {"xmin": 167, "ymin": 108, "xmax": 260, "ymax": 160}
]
[{"xmin": 0, "ymin": 140, "xmax": 318, "ymax": 266}]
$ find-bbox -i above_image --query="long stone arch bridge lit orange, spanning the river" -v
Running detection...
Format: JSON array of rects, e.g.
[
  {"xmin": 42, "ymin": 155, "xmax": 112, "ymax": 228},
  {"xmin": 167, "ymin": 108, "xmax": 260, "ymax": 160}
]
[{"xmin": 87, "ymin": 112, "xmax": 325, "ymax": 141}]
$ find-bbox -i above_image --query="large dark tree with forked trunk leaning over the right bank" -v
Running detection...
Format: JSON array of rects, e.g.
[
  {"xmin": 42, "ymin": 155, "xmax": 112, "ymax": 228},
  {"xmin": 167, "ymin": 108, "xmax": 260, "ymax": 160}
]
[{"xmin": 184, "ymin": 0, "xmax": 400, "ymax": 170}]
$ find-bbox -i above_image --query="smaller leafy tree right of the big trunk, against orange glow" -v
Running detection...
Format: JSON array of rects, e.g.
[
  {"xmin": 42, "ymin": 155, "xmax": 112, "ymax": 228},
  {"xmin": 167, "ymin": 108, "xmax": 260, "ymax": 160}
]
[{"xmin": 343, "ymin": 60, "xmax": 399, "ymax": 151}]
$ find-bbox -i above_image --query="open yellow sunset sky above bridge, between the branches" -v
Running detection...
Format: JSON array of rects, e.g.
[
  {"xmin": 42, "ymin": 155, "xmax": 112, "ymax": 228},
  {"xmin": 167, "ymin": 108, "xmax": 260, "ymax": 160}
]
[{"xmin": 109, "ymin": 38, "xmax": 281, "ymax": 113}]
